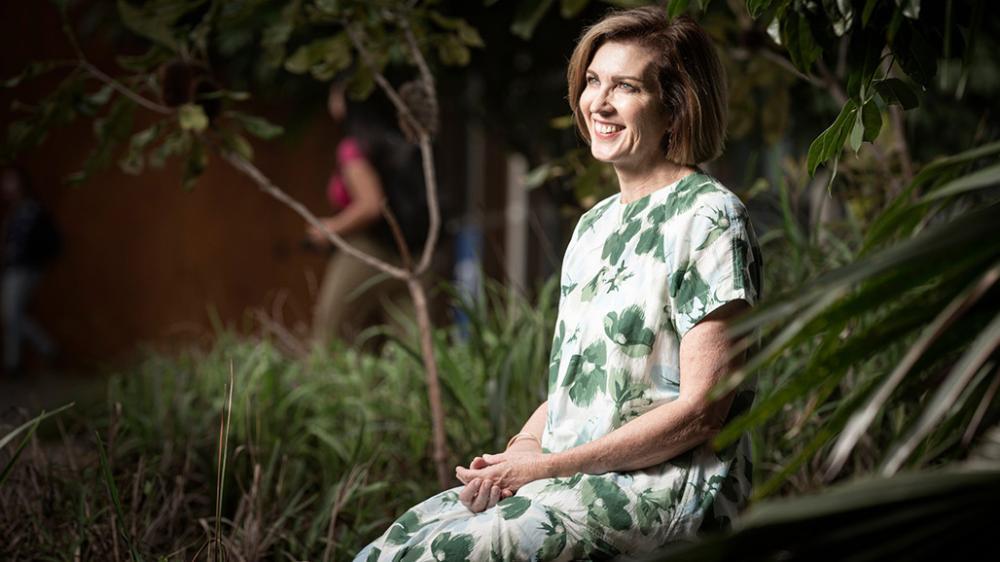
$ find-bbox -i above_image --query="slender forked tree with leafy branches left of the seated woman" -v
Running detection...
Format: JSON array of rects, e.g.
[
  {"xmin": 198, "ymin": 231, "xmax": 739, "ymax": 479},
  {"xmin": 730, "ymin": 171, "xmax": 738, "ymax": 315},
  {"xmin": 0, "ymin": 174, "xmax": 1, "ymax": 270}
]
[{"xmin": 4, "ymin": 0, "xmax": 496, "ymax": 487}]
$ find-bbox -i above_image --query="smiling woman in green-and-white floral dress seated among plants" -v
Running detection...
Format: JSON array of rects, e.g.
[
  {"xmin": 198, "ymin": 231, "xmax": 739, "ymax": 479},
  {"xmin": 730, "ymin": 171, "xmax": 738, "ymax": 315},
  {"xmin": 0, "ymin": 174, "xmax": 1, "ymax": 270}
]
[{"xmin": 358, "ymin": 7, "xmax": 760, "ymax": 560}]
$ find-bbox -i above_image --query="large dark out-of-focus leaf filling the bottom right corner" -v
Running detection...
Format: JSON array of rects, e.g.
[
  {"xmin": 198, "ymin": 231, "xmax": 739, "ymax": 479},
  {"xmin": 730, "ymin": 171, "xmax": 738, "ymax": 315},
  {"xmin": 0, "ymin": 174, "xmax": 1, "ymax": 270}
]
[{"xmin": 670, "ymin": 467, "xmax": 1000, "ymax": 562}]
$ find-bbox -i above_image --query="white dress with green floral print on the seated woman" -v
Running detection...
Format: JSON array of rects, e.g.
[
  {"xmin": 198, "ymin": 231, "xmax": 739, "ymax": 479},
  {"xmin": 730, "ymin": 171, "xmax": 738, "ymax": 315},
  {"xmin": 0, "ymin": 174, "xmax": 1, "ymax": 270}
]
[{"xmin": 355, "ymin": 173, "xmax": 761, "ymax": 561}]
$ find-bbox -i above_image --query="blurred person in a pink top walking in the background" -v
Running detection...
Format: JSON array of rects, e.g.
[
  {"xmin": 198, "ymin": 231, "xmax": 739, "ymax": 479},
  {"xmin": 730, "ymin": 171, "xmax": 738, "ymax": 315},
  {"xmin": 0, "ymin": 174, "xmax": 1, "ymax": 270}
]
[{"xmin": 307, "ymin": 82, "xmax": 427, "ymax": 345}]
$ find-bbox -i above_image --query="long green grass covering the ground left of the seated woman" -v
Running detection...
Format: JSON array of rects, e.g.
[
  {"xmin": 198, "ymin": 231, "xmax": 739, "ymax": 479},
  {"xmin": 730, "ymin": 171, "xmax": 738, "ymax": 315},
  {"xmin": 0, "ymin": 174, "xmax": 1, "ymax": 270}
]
[{"xmin": 0, "ymin": 282, "xmax": 557, "ymax": 560}]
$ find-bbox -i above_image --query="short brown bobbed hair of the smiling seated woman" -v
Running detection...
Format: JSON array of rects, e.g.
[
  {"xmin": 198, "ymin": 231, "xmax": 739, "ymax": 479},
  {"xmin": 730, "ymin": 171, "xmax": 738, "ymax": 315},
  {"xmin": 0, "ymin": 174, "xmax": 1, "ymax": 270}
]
[{"xmin": 566, "ymin": 6, "xmax": 728, "ymax": 165}]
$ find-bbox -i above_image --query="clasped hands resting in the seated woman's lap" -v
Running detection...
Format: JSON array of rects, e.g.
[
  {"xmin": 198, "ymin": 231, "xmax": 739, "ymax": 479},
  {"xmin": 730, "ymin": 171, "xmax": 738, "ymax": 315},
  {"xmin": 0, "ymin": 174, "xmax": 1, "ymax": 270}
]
[{"xmin": 455, "ymin": 450, "xmax": 549, "ymax": 513}]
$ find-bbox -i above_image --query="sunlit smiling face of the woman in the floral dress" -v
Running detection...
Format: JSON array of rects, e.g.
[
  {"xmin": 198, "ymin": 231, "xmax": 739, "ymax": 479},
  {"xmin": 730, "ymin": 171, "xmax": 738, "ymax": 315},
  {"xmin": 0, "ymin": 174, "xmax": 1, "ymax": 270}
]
[{"xmin": 579, "ymin": 42, "xmax": 670, "ymax": 168}]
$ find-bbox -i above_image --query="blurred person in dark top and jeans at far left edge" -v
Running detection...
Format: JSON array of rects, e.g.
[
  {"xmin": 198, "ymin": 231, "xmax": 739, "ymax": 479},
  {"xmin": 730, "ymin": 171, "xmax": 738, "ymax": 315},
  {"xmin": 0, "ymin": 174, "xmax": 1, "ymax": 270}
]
[{"xmin": 0, "ymin": 168, "xmax": 62, "ymax": 375}]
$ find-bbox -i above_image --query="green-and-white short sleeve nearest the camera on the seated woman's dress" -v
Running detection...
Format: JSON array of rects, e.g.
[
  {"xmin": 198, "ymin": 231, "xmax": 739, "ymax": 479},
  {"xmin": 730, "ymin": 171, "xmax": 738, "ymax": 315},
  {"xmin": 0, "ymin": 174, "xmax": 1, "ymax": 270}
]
[{"xmin": 667, "ymin": 200, "xmax": 761, "ymax": 338}]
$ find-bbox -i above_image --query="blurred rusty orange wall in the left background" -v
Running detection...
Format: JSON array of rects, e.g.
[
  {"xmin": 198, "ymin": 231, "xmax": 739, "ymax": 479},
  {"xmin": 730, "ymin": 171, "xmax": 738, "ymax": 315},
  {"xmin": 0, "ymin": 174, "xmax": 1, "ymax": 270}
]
[{"xmin": 0, "ymin": 2, "xmax": 335, "ymax": 365}]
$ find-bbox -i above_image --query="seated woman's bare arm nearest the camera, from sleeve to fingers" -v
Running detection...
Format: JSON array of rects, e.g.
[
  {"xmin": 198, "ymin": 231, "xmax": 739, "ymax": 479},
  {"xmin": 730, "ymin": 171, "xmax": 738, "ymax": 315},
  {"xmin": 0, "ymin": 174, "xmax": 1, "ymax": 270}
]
[{"xmin": 459, "ymin": 300, "xmax": 748, "ymax": 490}]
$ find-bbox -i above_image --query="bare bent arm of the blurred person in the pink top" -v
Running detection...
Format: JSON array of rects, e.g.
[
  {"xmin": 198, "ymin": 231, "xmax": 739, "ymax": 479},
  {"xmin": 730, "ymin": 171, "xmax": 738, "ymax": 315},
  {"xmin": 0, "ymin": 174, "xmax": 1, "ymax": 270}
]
[{"xmin": 309, "ymin": 158, "xmax": 385, "ymax": 243}]
